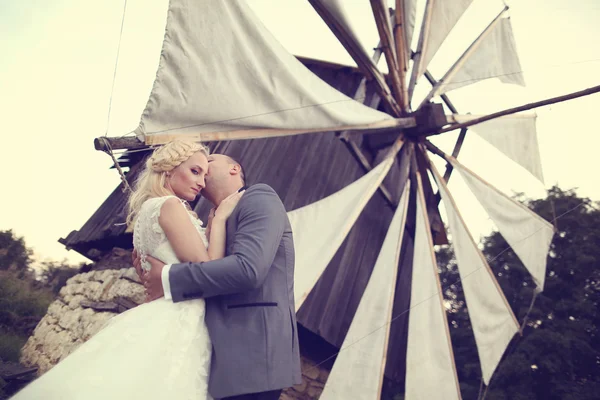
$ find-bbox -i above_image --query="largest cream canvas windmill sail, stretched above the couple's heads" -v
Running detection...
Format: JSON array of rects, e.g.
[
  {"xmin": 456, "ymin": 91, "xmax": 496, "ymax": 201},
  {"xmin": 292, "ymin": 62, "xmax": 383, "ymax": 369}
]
[{"xmin": 135, "ymin": 0, "xmax": 391, "ymax": 144}]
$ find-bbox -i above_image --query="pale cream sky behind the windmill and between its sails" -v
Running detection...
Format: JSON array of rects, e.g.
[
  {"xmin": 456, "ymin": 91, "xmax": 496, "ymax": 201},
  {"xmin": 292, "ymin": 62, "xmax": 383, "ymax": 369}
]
[{"xmin": 0, "ymin": 0, "xmax": 600, "ymax": 262}]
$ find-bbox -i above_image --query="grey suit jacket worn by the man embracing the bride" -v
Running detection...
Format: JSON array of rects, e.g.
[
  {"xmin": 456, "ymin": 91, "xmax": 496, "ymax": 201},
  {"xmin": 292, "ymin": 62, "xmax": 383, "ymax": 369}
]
[{"xmin": 169, "ymin": 184, "xmax": 301, "ymax": 398}]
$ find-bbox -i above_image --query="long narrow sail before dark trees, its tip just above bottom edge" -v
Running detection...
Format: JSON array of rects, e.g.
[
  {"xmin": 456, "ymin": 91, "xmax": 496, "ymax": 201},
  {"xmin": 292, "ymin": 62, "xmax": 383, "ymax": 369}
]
[{"xmin": 431, "ymin": 164, "xmax": 519, "ymax": 385}]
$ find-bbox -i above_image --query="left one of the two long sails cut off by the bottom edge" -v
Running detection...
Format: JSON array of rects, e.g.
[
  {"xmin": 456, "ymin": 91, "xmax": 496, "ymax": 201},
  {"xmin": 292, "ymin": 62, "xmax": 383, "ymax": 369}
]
[{"xmin": 320, "ymin": 184, "xmax": 410, "ymax": 400}]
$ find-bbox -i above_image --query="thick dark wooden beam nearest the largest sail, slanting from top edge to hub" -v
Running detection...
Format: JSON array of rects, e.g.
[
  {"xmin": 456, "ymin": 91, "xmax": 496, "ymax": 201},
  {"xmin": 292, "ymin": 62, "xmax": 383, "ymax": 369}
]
[{"xmin": 308, "ymin": 0, "xmax": 402, "ymax": 117}]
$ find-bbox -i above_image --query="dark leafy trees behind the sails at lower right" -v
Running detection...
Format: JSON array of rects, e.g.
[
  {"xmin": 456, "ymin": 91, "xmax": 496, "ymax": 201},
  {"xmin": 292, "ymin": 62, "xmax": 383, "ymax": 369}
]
[{"xmin": 438, "ymin": 187, "xmax": 600, "ymax": 400}]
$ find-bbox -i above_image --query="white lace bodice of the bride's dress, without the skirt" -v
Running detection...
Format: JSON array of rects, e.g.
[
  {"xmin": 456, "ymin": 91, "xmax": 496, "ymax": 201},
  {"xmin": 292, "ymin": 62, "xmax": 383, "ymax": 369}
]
[{"xmin": 133, "ymin": 196, "xmax": 208, "ymax": 269}]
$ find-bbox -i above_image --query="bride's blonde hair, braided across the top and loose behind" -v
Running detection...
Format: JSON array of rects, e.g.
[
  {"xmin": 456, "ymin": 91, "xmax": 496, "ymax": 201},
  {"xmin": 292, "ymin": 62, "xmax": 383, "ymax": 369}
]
[{"xmin": 126, "ymin": 139, "xmax": 209, "ymax": 230}]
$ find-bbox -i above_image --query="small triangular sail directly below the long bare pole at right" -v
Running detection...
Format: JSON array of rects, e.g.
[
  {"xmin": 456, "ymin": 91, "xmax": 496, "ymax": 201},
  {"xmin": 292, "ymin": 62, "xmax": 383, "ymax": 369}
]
[{"xmin": 452, "ymin": 113, "xmax": 544, "ymax": 182}]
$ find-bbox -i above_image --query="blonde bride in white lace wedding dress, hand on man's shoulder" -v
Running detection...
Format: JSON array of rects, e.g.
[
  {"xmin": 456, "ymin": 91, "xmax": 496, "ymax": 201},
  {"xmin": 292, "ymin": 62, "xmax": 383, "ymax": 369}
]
[{"xmin": 12, "ymin": 140, "xmax": 241, "ymax": 400}]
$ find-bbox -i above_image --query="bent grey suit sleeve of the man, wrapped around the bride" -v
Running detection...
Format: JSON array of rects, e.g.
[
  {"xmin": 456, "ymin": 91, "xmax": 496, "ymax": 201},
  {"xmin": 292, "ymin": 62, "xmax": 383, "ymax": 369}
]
[{"xmin": 169, "ymin": 185, "xmax": 286, "ymax": 302}]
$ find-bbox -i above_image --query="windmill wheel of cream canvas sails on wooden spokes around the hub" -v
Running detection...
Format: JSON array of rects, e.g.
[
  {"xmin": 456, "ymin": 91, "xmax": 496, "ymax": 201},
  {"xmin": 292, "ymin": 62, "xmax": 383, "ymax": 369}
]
[{"xmin": 95, "ymin": 0, "xmax": 600, "ymax": 399}]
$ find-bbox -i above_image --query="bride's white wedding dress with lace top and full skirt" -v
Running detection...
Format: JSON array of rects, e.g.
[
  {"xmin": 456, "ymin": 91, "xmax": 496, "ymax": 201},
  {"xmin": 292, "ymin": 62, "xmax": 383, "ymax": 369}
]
[{"xmin": 12, "ymin": 196, "xmax": 212, "ymax": 400}]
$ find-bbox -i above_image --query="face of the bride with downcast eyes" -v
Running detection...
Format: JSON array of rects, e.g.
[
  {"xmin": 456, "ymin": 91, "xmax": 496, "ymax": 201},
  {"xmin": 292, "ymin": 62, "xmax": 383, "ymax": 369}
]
[{"xmin": 166, "ymin": 152, "xmax": 208, "ymax": 201}]
